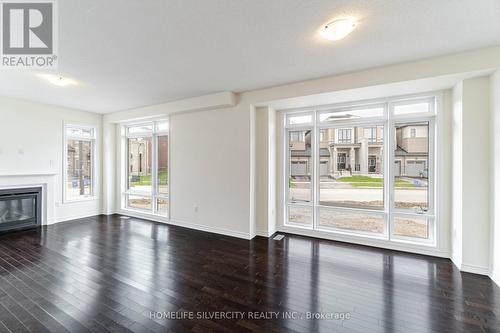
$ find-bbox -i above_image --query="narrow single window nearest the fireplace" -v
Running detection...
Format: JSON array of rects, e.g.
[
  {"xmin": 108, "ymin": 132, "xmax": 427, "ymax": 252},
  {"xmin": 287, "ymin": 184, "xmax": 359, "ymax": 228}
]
[{"xmin": 63, "ymin": 124, "xmax": 96, "ymax": 202}]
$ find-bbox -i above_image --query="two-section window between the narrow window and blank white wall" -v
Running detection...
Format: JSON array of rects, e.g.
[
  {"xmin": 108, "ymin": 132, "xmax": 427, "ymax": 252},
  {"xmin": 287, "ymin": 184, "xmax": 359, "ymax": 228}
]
[{"xmin": 123, "ymin": 120, "xmax": 169, "ymax": 216}]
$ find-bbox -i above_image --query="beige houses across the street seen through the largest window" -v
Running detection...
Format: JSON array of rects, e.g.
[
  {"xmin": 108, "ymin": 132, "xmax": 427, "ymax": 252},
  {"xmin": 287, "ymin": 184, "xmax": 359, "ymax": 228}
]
[{"xmin": 289, "ymin": 124, "xmax": 428, "ymax": 178}]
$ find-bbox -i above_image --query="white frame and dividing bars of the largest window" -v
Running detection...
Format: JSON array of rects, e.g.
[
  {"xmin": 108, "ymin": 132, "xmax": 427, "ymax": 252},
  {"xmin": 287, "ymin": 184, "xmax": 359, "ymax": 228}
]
[{"xmin": 279, "ymin": 92, "xmax": 442, "ymax": 249}]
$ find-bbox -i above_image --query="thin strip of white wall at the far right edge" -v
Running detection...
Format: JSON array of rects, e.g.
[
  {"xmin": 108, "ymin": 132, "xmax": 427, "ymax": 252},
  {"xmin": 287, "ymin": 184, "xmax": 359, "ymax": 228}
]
[{"xmin": 490, "ymin": 71, "xmax": 500, "ymax": 286}]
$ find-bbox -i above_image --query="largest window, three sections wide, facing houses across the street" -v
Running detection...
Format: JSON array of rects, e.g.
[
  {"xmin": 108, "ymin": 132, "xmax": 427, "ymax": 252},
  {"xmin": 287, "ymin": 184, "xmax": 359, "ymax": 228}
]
[{"xmin": 283, "ymin": 96, "xmax": 436, "ymax": 245}]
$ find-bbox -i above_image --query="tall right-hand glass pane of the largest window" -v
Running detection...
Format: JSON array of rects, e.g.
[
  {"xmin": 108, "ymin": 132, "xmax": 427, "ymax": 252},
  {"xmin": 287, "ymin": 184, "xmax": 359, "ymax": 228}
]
[{"xmin": 394, "ymin": 122, "xmax": 429, "ymax": 211}]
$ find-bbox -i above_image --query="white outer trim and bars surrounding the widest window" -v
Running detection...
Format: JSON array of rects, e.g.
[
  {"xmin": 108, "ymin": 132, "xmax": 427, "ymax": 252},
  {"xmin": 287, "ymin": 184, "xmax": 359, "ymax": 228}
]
[{"xmin": 277, "ymin": 92, "xmax": 448, "ymax": 255}]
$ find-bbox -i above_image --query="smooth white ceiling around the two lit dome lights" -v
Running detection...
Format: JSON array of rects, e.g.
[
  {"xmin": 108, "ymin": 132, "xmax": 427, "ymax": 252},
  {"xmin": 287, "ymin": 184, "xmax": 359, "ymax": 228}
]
[{"xmin": 0, "ymin": 0, "xmax": 500, "ymax": 112}]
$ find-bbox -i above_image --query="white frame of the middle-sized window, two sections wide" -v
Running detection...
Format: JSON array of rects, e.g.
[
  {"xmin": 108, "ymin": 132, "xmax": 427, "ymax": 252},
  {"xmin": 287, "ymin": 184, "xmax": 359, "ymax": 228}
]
[{"xmin": 121, "ymin": 117, "xmax": 171, "ymax": 220}]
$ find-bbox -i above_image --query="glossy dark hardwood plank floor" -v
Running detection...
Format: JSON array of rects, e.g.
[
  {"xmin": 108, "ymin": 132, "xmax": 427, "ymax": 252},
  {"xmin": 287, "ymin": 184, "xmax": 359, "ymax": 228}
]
[{"xmin": 0, "ymin": 215, "xmax": 500, "ymax": 333}]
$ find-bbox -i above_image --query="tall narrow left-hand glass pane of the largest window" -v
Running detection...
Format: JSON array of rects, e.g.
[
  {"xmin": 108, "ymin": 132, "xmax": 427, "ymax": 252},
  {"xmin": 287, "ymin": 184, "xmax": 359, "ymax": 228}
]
[{"xmin": 288, "ymin": 131, "xmax": 313, "ymax": 202}]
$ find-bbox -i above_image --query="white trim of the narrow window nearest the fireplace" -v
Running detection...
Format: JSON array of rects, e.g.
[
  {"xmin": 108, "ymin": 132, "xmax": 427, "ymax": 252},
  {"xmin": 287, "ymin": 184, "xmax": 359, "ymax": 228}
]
[{"xmin": 62, "ymin": 121, "xmax": 99, "ymax": 204}]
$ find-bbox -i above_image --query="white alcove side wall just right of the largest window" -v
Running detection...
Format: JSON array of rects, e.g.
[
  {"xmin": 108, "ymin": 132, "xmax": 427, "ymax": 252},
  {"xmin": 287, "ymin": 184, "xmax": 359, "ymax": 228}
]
[{"xmin": 452, "ymin": 76, "xmax": 491, "ymax": 274}]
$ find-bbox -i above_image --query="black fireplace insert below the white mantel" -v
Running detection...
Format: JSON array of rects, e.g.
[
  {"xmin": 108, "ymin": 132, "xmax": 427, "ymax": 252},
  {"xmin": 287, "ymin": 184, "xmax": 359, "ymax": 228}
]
[{"xmin": 0, "ymin": 187, "xmax": 42, "ymax": 233}]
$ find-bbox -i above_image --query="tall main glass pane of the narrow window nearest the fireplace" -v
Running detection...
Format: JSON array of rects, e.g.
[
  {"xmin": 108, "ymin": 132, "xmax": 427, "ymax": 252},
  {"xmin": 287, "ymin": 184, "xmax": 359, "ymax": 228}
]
[{"xmin": 66, "ymin": 140, "xmax": 92, "ymax": 200}]
